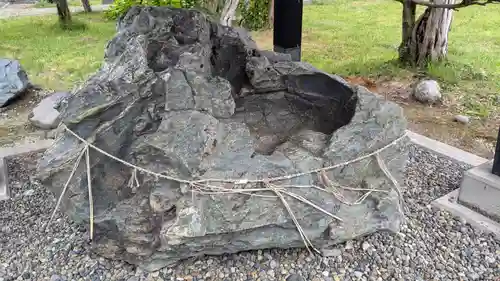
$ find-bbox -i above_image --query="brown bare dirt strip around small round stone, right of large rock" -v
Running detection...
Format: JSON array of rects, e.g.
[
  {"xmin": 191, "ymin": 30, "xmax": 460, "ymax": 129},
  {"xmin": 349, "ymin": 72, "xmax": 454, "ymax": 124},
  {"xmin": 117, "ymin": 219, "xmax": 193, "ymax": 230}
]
[{"xmin": 344, "ymin": 77, "xmax": 500, "ymax": 159}]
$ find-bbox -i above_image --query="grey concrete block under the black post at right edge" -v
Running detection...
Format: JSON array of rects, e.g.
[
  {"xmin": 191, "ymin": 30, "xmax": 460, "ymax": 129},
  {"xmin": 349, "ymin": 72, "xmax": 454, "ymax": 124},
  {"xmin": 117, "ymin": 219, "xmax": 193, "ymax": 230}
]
[{"xmin": 458, "ymin": 161, "xmax": 500, "ymax": 222}]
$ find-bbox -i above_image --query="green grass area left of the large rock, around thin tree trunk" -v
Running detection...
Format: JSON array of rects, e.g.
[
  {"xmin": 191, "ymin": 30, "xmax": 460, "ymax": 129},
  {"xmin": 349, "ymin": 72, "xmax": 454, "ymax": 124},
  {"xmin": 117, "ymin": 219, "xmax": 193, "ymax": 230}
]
[{"xmin": 0, "ymin": 13, "xmax": 115, "ymax": 90}]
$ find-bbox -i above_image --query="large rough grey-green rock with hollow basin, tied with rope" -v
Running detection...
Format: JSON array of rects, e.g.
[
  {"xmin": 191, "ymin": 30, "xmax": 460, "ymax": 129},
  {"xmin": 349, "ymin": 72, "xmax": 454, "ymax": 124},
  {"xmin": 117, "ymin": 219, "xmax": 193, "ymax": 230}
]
[{"xmin": 38, "ymin": 7, "xmax": 407, "ymax": 270}]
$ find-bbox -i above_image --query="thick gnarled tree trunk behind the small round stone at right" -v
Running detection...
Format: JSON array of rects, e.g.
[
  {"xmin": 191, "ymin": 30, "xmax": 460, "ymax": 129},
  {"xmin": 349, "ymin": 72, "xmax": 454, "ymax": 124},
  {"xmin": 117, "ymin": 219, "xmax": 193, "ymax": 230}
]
[{"xmin": 399, "ymin": 0, "xmax": 455, "ymax": 66}]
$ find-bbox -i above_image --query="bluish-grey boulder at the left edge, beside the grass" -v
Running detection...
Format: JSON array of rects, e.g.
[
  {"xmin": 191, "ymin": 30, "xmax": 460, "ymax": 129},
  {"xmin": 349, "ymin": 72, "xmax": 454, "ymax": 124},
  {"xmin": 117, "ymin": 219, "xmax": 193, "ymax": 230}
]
[{"xmin": 0, "ymin": 59, "xmax": 30, "ymax": 107}]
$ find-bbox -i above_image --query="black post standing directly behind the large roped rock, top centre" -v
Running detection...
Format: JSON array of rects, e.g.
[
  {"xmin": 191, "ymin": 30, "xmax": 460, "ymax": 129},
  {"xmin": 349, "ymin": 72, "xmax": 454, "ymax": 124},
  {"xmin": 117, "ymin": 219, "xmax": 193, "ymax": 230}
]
[{"xmin": 273, "ymin": 0, "xmax": 303, "ymax": 61}]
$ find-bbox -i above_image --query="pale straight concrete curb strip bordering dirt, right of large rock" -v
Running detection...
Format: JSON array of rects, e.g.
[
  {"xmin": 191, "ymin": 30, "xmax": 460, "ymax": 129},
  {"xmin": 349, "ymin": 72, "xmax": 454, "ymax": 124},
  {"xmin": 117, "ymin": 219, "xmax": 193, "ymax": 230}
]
[{"xmin": 407, "ymin": 131, "xmax": 488, "ymax": 167}]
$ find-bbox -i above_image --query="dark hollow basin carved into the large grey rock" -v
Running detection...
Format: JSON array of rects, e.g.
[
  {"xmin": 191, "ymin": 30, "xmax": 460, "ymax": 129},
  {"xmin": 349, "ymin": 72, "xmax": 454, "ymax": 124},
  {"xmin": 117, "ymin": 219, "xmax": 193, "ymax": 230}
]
[{"xmin": 233, "ymin": 73, "xmax": 358, "ymax": 156}]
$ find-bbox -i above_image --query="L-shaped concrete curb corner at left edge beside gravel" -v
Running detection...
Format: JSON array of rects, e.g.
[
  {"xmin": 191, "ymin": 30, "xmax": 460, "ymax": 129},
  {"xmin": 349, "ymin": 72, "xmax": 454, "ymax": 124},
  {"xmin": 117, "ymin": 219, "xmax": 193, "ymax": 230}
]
[{"xmin": 0, "ymin": 140, "xmax": 54, "ymax": 201}]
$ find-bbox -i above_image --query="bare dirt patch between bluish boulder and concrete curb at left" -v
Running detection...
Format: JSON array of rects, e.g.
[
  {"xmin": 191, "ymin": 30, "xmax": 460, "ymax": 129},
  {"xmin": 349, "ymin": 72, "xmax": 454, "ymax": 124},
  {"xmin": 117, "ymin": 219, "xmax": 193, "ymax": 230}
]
[{"xmin": 0, "ymin": 89, "xmax": 47, "ymax": 146}]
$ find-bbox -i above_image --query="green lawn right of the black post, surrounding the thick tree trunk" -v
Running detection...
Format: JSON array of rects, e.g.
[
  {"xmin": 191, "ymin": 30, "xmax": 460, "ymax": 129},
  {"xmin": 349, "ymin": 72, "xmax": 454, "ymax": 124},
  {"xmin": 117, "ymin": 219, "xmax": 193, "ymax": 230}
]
[{"xmin": 255, "ymin": 0, "xmax": 500, "ymax": 117}]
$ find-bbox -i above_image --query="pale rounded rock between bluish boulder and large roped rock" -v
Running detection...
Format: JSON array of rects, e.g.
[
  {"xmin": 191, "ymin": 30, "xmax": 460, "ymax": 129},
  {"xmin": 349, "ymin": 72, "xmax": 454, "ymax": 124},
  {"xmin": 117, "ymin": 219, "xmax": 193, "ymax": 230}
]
[{"xmin": 28, "ymin": 92, "xmax": 70, "ymax": 130}]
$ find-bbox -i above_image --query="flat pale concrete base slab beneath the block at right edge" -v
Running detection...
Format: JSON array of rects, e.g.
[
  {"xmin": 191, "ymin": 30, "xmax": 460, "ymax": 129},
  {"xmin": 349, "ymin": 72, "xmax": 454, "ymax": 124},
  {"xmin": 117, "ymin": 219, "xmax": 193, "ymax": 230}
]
[{"xmin": 431, "ymin": 189, "xmax": 500, "ymax": 236}]
